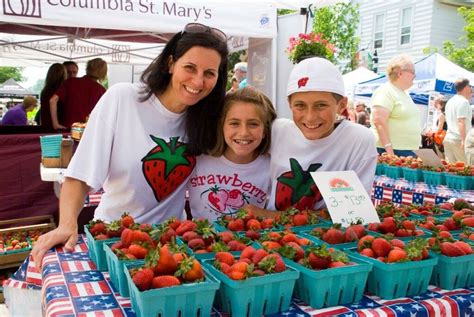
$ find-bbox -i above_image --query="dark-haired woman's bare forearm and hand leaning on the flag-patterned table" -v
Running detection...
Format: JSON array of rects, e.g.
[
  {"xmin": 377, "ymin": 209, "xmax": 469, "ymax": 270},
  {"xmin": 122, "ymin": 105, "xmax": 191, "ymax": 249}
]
[{"xmin": 31, "ymin": 177, "xmax": 90, "ymax": 269}]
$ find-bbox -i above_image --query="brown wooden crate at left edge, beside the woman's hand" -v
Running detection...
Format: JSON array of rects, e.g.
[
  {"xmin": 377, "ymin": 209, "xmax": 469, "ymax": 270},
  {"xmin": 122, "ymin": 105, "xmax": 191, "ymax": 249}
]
[{"xmin": 0, "ymin": 216, "xmax": 56, "ymax": 269}]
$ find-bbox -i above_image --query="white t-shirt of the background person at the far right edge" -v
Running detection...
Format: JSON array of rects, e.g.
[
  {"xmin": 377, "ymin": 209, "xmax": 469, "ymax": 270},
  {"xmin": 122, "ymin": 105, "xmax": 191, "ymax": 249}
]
[{"xmin": 444, "ymin": 95, "xmax": 472, "ymax": 141}]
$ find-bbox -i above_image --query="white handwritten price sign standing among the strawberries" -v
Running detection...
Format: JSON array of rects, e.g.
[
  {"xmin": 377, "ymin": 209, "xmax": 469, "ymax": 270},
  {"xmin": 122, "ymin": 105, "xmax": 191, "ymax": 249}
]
[{"xmin": 311, "ymin": 171, "xmax": 380, "ymax": 227}]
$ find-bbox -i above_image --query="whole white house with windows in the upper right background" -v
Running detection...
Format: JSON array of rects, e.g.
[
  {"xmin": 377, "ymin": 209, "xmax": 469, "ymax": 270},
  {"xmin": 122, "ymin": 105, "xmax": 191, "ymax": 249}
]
[{"xmin": 353, "ymin": 0, "xmax": 468, "ymax": 73}]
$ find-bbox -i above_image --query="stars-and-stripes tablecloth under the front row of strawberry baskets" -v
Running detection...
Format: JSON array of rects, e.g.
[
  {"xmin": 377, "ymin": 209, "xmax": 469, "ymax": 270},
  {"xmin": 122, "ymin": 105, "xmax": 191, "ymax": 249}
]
[{"xmin": 4, "ymin": 236, "xmax": 474, "ymax": 317}]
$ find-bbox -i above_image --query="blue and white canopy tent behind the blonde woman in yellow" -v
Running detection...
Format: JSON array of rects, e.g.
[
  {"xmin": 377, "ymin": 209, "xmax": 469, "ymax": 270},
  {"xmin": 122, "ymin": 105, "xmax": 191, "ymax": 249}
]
[{"xmin": 354, "ymin": 53, "xmax": 474, "ymax": 105}]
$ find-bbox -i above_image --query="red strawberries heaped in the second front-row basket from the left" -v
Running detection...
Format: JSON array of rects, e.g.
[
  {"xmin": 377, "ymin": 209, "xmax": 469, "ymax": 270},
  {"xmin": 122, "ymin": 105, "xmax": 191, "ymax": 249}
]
[{"xmin": 214, "ymin": 246, "xmax": 286, "ymax": 281}]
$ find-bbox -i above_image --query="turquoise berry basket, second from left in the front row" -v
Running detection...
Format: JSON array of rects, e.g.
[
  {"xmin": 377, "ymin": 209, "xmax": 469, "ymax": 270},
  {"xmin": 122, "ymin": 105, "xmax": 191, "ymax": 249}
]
[{"xmin": 203, "ymin": 259, "xmax": 300, "ymax": 317}]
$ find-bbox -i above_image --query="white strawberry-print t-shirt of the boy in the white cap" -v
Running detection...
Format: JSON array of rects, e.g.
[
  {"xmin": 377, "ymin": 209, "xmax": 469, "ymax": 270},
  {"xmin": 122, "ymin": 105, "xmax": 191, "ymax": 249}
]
[{"xmin": 268, "ymin": 119, "xmax": 377, "ymax": 210}]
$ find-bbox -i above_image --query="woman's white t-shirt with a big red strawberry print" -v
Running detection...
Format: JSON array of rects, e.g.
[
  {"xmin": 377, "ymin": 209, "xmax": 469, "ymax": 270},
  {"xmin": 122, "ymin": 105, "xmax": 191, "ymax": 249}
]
[{"xmin": 66, "ymin": 83, "xmax": 191, "ymax": 223}]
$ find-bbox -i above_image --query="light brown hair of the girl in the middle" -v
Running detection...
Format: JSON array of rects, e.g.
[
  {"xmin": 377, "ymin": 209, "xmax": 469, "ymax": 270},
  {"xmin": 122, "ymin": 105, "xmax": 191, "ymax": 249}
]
[{"xmin": 209, "ymin": 86, "xmax": 277, "ymax": 157}]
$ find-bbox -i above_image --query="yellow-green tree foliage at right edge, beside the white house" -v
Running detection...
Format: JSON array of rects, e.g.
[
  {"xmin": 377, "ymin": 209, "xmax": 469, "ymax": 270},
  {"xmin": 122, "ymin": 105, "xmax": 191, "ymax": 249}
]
[{"xmin": 443, "ymin": 7, "xmax": 474, "ymax": 72}]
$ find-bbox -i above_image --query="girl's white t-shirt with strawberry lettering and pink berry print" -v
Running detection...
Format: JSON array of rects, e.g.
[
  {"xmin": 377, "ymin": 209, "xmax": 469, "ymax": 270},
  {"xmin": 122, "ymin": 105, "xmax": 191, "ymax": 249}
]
[{"xmin": 188, "ymin": 155, "xmax": 270, "ymax": 220}]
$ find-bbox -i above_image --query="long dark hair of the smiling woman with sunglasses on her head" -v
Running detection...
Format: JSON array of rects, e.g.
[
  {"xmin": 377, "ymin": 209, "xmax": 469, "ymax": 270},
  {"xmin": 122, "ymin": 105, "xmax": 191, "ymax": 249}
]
[{"xmin": 140, "ymin": 32, "xmax": 229, "ymax": 155}]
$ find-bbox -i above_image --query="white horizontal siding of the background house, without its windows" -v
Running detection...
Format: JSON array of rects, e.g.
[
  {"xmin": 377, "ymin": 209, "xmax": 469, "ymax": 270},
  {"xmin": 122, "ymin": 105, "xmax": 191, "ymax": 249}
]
[{"xmin": 353, "ymin": 0, "xmax": 465, "ymax": 72}]
